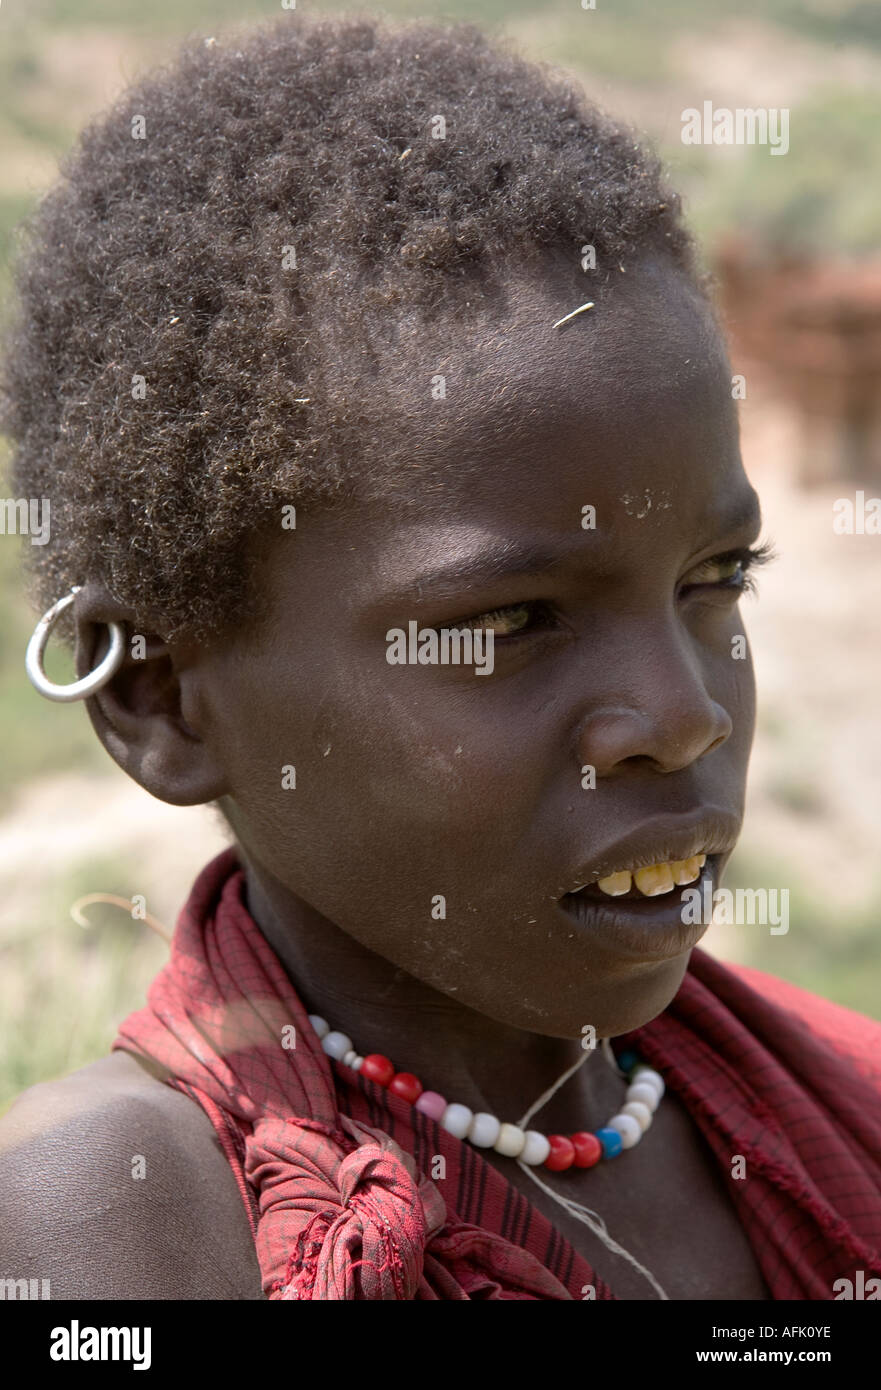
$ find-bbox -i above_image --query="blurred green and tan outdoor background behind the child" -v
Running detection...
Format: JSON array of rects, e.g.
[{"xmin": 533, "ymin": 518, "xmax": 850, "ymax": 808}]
[{"xmin": 0, "ymin": 0, "xmax": 881, "ymax": 1109}]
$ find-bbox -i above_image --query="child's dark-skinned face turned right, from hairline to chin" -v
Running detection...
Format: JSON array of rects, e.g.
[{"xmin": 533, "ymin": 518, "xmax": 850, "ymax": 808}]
[{"xmin": 190, "ymin": 255, "xmax": 759, "ymax": 1037}]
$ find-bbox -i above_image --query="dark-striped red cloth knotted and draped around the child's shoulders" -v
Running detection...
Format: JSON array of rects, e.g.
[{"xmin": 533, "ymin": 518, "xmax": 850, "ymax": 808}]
[{"xmin": 114, "ymin": 849, "xmax": 881, "ymax": 1300}]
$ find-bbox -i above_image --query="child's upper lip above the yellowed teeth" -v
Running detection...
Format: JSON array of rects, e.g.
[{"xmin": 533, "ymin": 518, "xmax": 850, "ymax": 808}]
[{"xmin": 561, "ymin": 806, "xmax": 741, "ymax": 901}]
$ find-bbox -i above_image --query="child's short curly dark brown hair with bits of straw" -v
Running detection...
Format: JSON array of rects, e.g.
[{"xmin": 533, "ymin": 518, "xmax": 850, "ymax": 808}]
[{"xmin": 0, "ymin": 14, "xmax": 700, "ymax": 637}]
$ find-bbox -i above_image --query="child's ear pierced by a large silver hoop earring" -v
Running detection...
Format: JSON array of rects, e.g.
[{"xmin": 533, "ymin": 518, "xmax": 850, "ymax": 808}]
[{"xmin": 75, "ymin": 581, "xmax": 227, "ymax": 806}]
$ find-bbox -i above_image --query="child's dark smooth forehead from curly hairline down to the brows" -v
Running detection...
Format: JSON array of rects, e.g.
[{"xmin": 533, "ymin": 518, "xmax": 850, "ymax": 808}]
[{"xmin": 250, "ymin": 265, "xmax": 756, "ymax": 617}]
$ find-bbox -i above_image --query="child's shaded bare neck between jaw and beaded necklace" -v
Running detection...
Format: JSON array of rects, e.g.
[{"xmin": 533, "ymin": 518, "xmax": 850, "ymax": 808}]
[{"xmin": 240, "ymin": 851, "xmax": 623, "ymax": 1131}]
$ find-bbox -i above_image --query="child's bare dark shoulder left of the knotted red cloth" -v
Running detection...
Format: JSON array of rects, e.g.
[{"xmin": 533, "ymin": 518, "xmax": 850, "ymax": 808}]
[{"xmin": 0, "ymin": 1052, "xmax": 263, "ymax": 1300}]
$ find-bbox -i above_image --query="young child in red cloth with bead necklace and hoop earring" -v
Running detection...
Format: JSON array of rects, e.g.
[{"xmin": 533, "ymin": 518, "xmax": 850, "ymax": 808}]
[{"xmin": 0, "ymin": 14, "xmax": 881, "ymax": 1300}]
